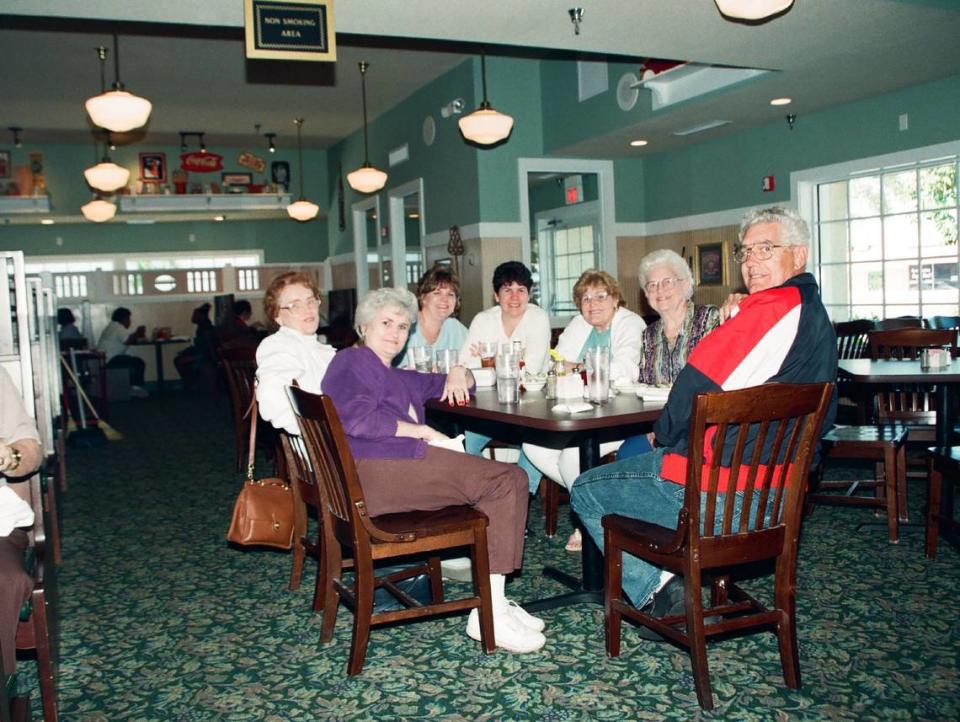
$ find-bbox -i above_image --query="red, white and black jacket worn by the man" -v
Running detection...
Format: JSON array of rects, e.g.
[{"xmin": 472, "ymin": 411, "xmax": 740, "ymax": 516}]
[{"xmin": 654, "ymin": 273, "xmax": 837, "ymax": 488}]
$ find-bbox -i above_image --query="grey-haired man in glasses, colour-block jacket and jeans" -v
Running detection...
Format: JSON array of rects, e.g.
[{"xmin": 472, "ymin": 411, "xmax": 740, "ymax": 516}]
[{"xmin": 570, "ymin": 207, "xmax": 837, "ymax": 639}]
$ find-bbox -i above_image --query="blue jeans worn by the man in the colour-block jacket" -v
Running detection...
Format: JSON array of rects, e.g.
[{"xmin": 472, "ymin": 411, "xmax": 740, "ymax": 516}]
[{"xmin": 570, "ymin": 448, "xmax": 743, "ymax": 607}]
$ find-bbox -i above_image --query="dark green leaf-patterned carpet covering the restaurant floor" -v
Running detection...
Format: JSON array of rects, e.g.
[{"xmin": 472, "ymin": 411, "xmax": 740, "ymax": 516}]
[{"xmin": 21, "ymin": 394, "xmax": 960, "ymax": 722}]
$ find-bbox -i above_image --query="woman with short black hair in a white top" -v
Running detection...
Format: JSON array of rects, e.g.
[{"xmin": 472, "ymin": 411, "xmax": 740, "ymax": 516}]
[{"xmin": 460, "ymin": 261, "xmax": 550, "ymax": 494}]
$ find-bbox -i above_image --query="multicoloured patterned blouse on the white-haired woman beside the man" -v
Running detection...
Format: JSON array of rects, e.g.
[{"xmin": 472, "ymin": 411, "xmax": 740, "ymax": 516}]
[{"xmin": 640, "ymin": 301, "xmax": 720, "ymax": 386}]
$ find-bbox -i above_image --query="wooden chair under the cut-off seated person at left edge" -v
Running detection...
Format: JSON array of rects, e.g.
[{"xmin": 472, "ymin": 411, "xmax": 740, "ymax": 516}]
[{"xmin": 17, "ymin": 474, "xmax": 58, "ymax": 722}]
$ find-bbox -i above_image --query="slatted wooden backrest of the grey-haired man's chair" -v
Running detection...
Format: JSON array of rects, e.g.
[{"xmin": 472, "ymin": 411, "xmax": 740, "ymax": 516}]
[{"xmin": 685, "ymin": 383, "xmax": 833, "ymax": 558}]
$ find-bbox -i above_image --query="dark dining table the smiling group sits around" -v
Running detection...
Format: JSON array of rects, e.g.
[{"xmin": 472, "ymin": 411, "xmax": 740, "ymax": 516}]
[{"xmin": 427, "ymin": 387, "xmax": 665, "ymax": 611}]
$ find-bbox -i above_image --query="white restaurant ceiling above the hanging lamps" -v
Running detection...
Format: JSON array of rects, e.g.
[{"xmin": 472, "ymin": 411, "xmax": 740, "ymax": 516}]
[{"xmin": 0, "ymin": 0, "xmax": 960, "ymax": 157}]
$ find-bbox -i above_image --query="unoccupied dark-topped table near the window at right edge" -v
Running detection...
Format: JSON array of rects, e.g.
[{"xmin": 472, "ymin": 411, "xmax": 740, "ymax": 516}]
[{"xmin": 837, "ymin": 358, "xmax": 960, "ymax": 546}]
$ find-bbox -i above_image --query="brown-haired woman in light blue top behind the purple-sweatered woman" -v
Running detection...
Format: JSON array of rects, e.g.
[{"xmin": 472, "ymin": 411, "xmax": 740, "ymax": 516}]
[{"xmin": 397, "ymin": 264, "xmax": 467, "ymax": 369}]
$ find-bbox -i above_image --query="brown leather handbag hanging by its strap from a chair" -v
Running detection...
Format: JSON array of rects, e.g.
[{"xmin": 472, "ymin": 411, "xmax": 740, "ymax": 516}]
[{"xmin": 227, "ymin": 397, "xmax": 293, "ymax": 549}]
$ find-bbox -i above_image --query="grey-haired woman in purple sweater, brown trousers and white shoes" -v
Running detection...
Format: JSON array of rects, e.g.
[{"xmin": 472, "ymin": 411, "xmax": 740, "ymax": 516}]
[{"xmin": 323, "ymin": 288, "xmax": 546, "ymax": 653}]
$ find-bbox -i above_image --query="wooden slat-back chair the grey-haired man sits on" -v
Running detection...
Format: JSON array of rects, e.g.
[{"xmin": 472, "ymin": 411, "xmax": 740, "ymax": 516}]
[{"xmin": 603, "ymin": 383, "xmax": 833, "ymax": 709}]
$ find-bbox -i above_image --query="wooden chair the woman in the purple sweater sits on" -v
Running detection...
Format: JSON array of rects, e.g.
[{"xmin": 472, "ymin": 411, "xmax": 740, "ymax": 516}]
[{"xmin": 288, "ymin": 388, "xmax": 495, "ymax": 675}]
